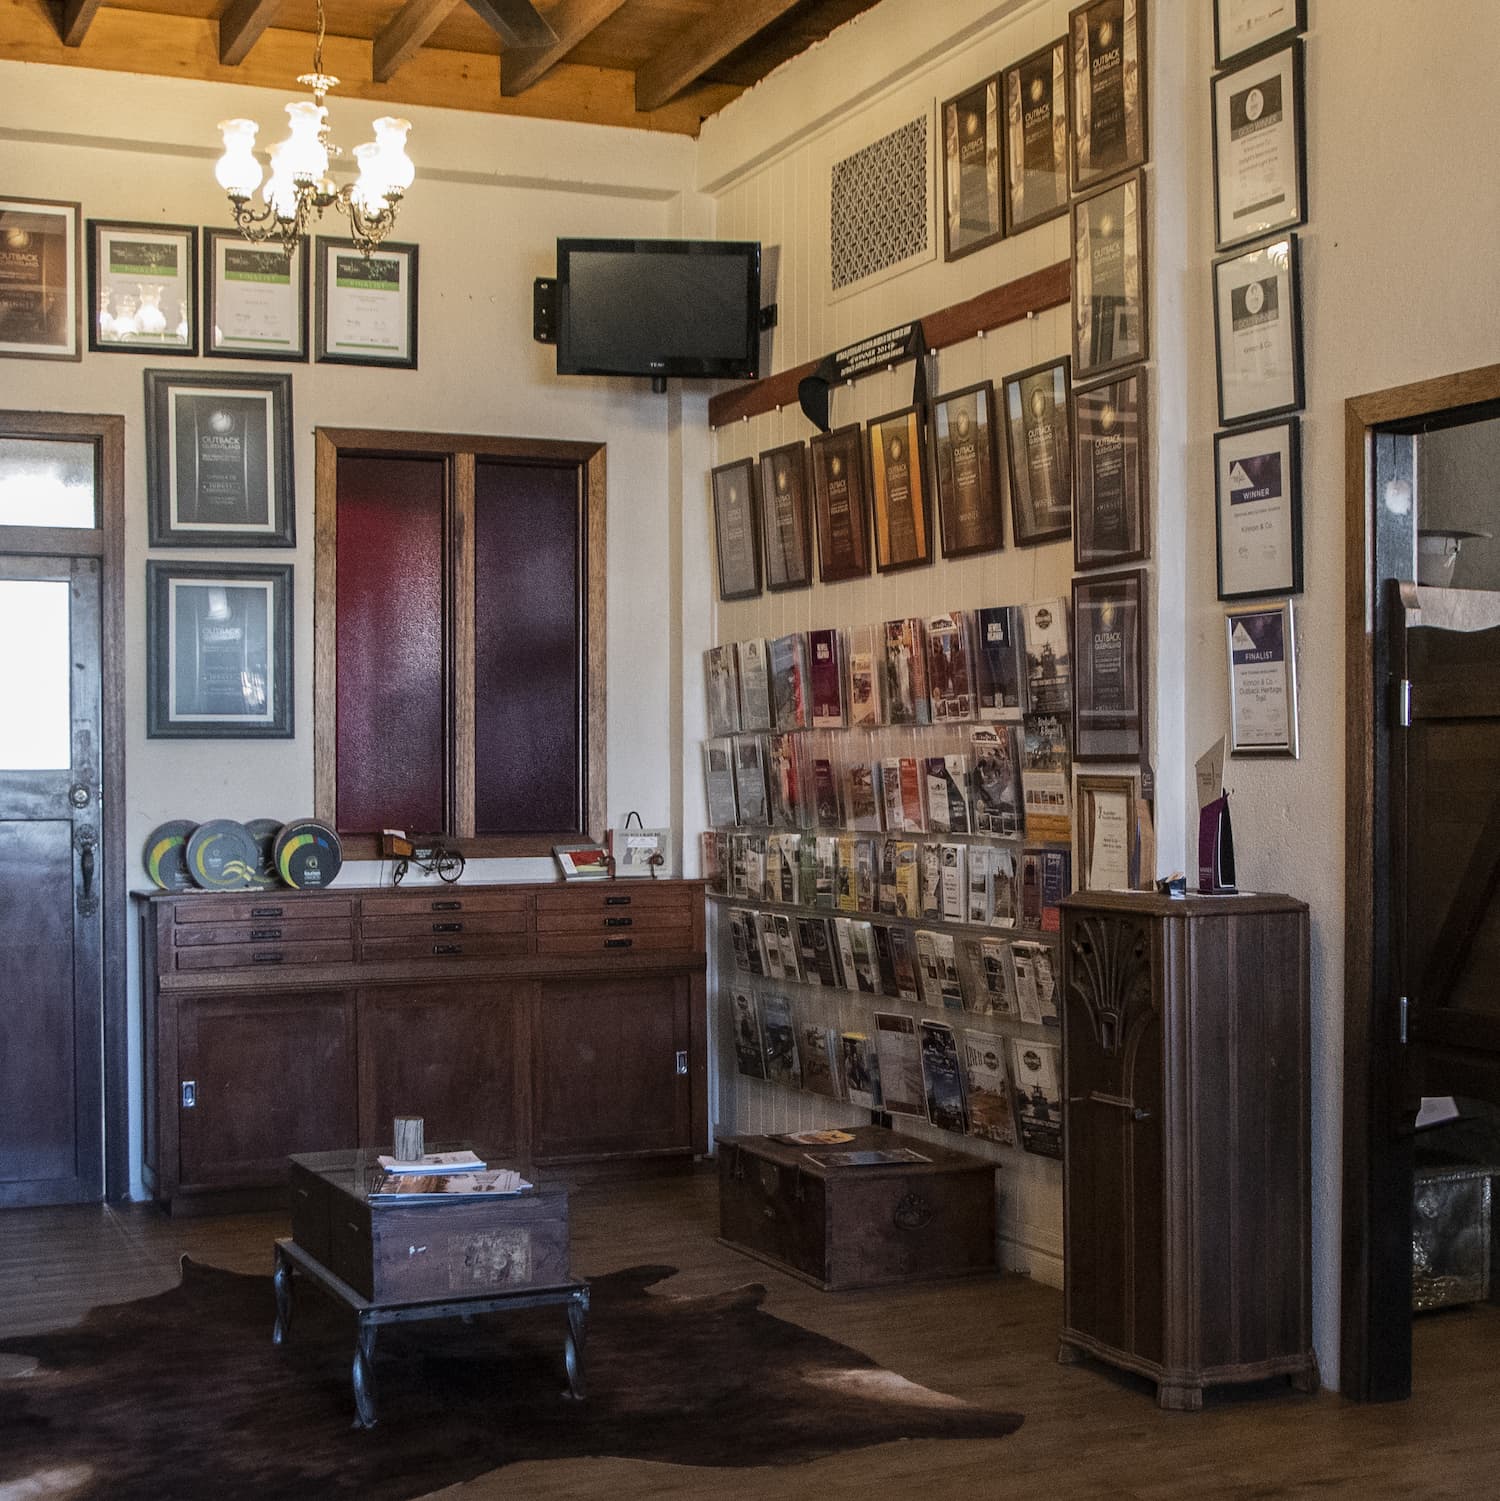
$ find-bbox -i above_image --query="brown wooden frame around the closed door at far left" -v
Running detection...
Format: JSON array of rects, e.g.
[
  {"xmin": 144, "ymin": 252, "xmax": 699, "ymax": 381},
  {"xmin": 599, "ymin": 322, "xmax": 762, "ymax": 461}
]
[{"xmin": 0, "ymin": 411, "xmax": 131, "ymax": 1201}]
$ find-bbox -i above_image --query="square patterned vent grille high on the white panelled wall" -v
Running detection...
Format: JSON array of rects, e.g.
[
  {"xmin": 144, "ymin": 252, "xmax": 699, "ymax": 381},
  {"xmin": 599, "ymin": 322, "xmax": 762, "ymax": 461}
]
[{"xmin": 829, "ymin": 114, "xmax": 931, "ymax": 291}]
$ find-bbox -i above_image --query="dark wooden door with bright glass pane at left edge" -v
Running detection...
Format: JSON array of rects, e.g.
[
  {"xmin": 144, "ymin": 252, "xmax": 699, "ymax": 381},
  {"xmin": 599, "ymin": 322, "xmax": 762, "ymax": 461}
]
[{"xmin": 0, "ymin": 557, "xmax": 105, "ymax": 1205}]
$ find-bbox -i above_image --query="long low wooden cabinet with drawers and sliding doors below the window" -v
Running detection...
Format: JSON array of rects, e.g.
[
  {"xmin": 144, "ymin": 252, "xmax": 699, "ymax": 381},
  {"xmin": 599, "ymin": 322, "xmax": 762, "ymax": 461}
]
[{"xmin": 141, "ymin": 881, "xmax": 707, "ymax": 1210}]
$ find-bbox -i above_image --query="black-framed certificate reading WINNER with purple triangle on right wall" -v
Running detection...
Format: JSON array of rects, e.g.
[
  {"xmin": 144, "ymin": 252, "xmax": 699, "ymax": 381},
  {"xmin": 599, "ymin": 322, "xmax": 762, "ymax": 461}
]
[{"xmin": 1213, "ymin": 417, "xmax": 1302, "ymax": 599}]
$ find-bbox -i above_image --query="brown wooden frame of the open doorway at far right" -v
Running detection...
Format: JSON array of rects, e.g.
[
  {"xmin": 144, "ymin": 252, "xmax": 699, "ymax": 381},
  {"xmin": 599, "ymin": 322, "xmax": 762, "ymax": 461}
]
[{"xmin": 1339, "ymin": 365, "xmax": 1500, "ymax": 1400}]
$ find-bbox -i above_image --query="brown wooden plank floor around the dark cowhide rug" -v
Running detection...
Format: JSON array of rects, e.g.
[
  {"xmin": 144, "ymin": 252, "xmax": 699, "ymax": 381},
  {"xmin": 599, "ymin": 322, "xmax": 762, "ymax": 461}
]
[{"xmin": 0, "ymin": 1171, "xmax": 1500, "ymax": 1501}]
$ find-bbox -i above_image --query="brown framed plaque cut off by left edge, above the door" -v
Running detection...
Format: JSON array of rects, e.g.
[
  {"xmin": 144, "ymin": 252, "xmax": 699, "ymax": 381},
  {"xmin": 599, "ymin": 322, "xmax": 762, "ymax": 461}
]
[{"xmin": 0, "ymin": 198, "xmax": 83, "ymax": 360}]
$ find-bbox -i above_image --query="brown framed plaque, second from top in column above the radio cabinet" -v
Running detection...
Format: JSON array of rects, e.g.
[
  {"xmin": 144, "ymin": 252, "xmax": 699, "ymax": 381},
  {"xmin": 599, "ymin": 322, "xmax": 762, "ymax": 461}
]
[{"xmin": 1074, "ymin": 173, "xmax": 1146, "ymax": 380}]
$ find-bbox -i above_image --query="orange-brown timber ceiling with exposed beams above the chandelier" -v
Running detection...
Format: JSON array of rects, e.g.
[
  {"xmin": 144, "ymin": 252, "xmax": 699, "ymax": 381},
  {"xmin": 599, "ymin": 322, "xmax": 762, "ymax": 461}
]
[{"xmin": 0, "ymin": 0, "xmax": 877, "ymax": 135}]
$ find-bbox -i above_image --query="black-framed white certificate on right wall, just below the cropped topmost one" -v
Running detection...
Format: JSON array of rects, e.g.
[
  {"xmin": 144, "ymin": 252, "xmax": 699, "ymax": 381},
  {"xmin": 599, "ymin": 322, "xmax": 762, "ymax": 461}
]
[{"xmin": 1213, "ymin": 41, "xmax": 1308, "ymax": 251}]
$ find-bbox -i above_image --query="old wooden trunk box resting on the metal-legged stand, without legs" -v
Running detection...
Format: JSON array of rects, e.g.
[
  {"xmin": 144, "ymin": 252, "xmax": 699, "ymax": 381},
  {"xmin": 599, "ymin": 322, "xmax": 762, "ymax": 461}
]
[{"xmin": 291, "ymin": 1151, "xmax": 569, "ymax": 1303}]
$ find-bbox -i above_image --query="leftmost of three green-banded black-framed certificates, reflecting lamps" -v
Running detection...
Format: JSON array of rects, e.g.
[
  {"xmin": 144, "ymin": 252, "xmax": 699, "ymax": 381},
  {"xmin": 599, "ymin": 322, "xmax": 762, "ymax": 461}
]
[{"xmin": 89, "ymin": 219, "xmax": 198, "ymax": 354}]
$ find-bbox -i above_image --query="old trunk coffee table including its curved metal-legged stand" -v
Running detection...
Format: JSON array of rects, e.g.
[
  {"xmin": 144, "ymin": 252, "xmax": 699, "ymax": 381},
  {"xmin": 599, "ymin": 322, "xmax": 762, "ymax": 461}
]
[{"xmin": 272, "ymin": 1150, "xmax": 589, "ymax": 1427}]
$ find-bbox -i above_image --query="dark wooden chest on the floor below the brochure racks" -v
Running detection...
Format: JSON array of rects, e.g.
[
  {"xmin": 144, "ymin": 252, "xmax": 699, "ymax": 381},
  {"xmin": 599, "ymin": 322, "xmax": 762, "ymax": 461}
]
[{"xmin": 719, "ymin": 1126, "xmax": 995, "ymax": 1291}]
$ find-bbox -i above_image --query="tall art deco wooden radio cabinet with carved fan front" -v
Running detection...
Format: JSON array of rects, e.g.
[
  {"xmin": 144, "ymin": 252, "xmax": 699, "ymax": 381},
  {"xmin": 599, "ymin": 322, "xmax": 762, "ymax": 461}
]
[{"xmin": 1059, "ymin": 892, "xmax": 1318, "ymax": 1409}]
